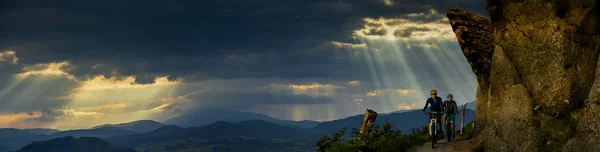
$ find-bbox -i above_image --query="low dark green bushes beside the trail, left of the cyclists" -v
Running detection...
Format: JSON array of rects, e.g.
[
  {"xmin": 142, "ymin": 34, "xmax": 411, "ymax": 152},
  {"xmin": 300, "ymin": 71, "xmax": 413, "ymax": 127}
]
[{"xmin": 317, "ymin": 122, "xmax": 429, "ymax": 152}]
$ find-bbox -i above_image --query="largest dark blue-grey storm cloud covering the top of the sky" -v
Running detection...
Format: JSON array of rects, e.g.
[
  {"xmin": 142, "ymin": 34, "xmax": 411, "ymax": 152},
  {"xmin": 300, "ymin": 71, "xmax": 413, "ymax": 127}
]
[{"xmin": 0, "ymin": 0, "xmax": 484, "ymax": 78}]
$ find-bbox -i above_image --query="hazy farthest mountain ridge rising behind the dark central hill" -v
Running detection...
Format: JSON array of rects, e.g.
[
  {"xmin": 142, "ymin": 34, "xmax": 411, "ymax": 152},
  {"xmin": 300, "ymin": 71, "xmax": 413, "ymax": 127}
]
[{"xmin": 164, "ymin": 109, "xmax": 319, "ymax": 128}]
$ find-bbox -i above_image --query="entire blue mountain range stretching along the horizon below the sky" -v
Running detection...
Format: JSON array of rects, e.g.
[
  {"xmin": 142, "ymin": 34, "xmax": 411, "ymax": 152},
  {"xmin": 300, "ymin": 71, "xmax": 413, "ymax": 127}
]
[{"xmin": 0, "ymin": 108, "xmax": 475, "ymax": 152}]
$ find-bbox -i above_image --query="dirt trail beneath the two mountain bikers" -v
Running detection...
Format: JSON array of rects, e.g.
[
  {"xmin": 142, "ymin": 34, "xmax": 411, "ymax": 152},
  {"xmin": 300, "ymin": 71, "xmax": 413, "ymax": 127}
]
[{"xmin": 415, "ymin": 135, "xmax": 476, "ymax": 152}]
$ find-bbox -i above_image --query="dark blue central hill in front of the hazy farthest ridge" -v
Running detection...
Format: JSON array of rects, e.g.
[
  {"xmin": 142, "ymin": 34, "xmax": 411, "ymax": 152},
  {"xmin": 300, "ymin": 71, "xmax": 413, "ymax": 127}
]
[{"xmin": 107, "ymin": 120, "xmax": 324, "ymax": 151}]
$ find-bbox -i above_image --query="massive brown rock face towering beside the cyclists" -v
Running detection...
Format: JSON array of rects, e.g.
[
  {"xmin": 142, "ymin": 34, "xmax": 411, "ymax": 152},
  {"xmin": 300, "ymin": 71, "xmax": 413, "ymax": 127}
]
[{"xmin": 447, "ymin": 0, "xmax": 600, "ymax": 151}]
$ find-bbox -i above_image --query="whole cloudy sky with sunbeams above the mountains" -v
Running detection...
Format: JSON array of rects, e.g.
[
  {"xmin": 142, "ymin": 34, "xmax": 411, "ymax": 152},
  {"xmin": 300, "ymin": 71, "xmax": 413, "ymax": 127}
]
[{"xmin": 0, "ymin": 0, "xmax": 487, "ymax": 129}]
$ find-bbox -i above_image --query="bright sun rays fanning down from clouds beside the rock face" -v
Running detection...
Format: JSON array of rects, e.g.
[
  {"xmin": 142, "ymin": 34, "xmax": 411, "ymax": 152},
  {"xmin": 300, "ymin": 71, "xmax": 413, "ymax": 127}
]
[{"xmin": 355, "ymin": 10, "xmax": 470, "ymax": 114}]
